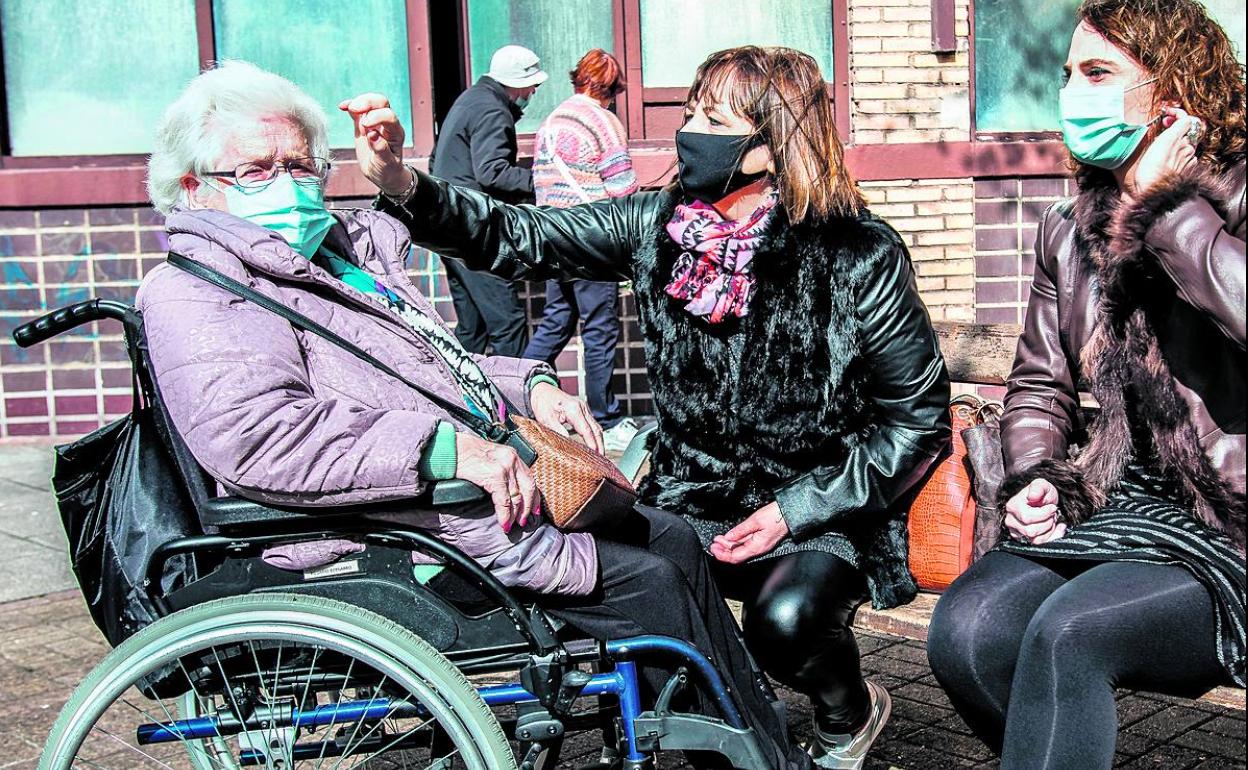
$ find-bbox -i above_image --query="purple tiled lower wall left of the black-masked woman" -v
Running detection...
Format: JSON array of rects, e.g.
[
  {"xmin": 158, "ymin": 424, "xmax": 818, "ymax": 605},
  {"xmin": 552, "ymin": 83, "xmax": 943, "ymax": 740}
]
[{"xmin": 0, "ymin": 200, "xmax": 650, "ymax": 439}]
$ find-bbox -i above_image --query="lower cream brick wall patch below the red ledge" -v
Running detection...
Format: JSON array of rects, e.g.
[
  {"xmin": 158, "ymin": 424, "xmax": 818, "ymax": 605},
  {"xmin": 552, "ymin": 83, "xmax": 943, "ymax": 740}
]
[{"xmin": 862, "ymin": 178, "xmax": 975, "ymax": 321}]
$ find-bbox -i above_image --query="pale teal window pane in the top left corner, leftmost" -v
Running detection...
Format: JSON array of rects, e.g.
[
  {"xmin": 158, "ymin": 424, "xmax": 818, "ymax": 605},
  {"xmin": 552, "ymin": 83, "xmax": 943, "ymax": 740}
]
[{"xmin": 0, "ymin": 0, "xmax": 198, "ymax": 155}]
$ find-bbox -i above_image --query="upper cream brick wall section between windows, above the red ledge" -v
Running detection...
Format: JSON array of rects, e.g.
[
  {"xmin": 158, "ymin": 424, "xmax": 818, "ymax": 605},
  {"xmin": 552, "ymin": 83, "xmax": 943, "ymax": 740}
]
[{"xmin": 850, "ymin": 0, "xmax": 971, "ymax": 144}]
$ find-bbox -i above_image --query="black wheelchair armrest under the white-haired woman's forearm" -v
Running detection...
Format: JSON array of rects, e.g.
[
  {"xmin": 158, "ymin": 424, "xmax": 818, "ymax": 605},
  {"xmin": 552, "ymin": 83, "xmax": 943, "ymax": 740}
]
[{"xmin": 200, "ymin": 479, "xmax": 487, "ymax": 529}]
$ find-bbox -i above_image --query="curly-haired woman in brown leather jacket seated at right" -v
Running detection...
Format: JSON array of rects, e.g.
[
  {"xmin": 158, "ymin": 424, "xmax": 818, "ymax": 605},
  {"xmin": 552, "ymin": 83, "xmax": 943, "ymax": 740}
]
[{"xmin": 927, "ymin": 0, "xmax": 1248, "ymax": 770}]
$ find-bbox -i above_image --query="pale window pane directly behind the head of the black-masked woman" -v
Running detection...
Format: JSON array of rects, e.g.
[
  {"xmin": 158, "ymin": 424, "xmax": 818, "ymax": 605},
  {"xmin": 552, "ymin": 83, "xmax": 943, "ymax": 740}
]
[{"xmin": 641, "ymin": 0, "xmax": 832, "ymax": 87}]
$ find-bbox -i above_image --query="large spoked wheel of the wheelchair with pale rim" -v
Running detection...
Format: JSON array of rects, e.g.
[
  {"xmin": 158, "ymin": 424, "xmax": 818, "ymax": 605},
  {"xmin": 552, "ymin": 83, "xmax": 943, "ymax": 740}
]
[{"xmin": 39, "ymin": 594, "xmax": 515, "ymax": 770}]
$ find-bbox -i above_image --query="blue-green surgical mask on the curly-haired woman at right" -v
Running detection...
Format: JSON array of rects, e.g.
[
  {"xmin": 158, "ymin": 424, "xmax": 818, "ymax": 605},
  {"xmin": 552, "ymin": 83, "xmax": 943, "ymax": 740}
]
[{"xmin": 1058, "ymin": 77, "xmax": 1157, "ymax": 168}]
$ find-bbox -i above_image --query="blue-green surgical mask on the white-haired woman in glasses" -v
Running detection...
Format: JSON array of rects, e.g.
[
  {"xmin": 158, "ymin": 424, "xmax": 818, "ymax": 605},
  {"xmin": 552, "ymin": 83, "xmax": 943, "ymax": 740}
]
[{"xmin": 209, "ymin": 173, "xmax": 334, "ymax": 258}]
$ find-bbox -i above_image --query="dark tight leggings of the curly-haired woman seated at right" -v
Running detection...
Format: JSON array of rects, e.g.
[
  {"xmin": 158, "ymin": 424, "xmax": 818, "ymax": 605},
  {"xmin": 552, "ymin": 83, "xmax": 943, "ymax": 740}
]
[{"xmin": 927, "ymin": 552, "xmax": 1224, "ymax": 770}]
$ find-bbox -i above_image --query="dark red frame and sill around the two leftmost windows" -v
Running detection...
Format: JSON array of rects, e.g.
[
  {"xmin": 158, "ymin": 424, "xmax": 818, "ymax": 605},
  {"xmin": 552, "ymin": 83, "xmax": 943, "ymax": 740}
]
[{"xmin": 0, "ymin": 0, "xmax": 433, "ymax": 208}]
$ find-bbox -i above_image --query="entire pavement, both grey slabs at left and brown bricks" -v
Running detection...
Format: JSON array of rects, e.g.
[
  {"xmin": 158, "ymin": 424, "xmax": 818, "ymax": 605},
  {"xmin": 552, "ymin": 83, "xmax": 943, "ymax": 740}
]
[{"xmin": 0, "ymin": 444, "xmax": 1246, "ymax": 770}]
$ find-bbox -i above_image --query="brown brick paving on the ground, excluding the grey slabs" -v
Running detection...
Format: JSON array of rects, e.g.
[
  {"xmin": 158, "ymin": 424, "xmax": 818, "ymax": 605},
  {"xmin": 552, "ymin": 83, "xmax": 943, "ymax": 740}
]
[{"xmin": 0, "ymin": 590, "xmax": 1244, "ymax": 770}]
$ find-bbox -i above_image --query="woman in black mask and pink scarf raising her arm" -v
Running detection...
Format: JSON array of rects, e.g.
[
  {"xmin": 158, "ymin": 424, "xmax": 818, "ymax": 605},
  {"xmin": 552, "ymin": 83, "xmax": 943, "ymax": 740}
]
[{"xmin": 344, "ymin": 46, "xmax": 950, "ymax": 768}]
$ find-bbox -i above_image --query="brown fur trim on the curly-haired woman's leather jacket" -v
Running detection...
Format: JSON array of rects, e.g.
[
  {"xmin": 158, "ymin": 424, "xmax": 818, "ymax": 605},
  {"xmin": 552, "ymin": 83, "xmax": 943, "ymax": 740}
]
[{"xmin": 1072, "ymin": 164, "xmax": 1244, "ymax": 547}]
